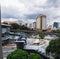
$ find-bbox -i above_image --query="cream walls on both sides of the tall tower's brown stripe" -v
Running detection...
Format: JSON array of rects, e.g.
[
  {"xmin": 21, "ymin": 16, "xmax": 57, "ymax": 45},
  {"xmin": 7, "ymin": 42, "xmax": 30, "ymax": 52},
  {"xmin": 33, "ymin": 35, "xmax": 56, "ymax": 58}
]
[{"xmin": 36, "ymin": 16, "xmax": 46, "ymax": 30}]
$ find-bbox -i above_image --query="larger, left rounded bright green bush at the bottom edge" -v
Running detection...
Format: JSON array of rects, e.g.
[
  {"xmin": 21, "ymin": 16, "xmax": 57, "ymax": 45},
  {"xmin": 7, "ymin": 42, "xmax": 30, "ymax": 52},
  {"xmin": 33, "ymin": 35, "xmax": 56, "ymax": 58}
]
[{"xmin": 7, "ymin": 49, "xmax": 28, "ymax": 59}]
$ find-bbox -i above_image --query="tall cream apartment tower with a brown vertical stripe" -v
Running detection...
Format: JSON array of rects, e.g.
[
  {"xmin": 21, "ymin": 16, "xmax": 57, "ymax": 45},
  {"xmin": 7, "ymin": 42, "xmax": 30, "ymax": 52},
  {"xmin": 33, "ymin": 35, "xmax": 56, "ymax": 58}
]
[{"xmin": 36, "ymin": 14, "xmax": 46, "ymax": 31}]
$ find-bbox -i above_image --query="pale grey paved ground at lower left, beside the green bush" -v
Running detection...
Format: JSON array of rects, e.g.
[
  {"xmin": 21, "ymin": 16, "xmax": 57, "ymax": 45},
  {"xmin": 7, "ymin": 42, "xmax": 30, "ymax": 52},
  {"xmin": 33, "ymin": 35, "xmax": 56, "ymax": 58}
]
[{"xmin": 3, "ymin": 46, "xmax": 16, "ymax": 59}]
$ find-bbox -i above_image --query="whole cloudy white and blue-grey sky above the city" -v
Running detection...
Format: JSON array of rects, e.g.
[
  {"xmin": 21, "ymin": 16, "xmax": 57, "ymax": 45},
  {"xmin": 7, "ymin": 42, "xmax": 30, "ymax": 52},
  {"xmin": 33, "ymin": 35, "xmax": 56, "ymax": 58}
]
[{"xmin": 0, "ymin": 0, "xmax": 60, "ymax": 25}]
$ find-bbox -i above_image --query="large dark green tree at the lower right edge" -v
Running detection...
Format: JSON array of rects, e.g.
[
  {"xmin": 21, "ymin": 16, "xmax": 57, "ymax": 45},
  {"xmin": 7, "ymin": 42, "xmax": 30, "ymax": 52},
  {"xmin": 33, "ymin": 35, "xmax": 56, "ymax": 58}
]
[{"xmin": 46, "ymin": 38, "xmax": 60, "ymax": 59}]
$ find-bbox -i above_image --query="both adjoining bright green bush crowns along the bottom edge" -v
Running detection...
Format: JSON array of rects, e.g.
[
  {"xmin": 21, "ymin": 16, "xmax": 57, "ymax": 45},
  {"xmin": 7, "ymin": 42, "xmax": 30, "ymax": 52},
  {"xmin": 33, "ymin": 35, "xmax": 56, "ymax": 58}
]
[{"xmin": 7, "ymin": 49, "xmax": 42, "ymax": 59}]
